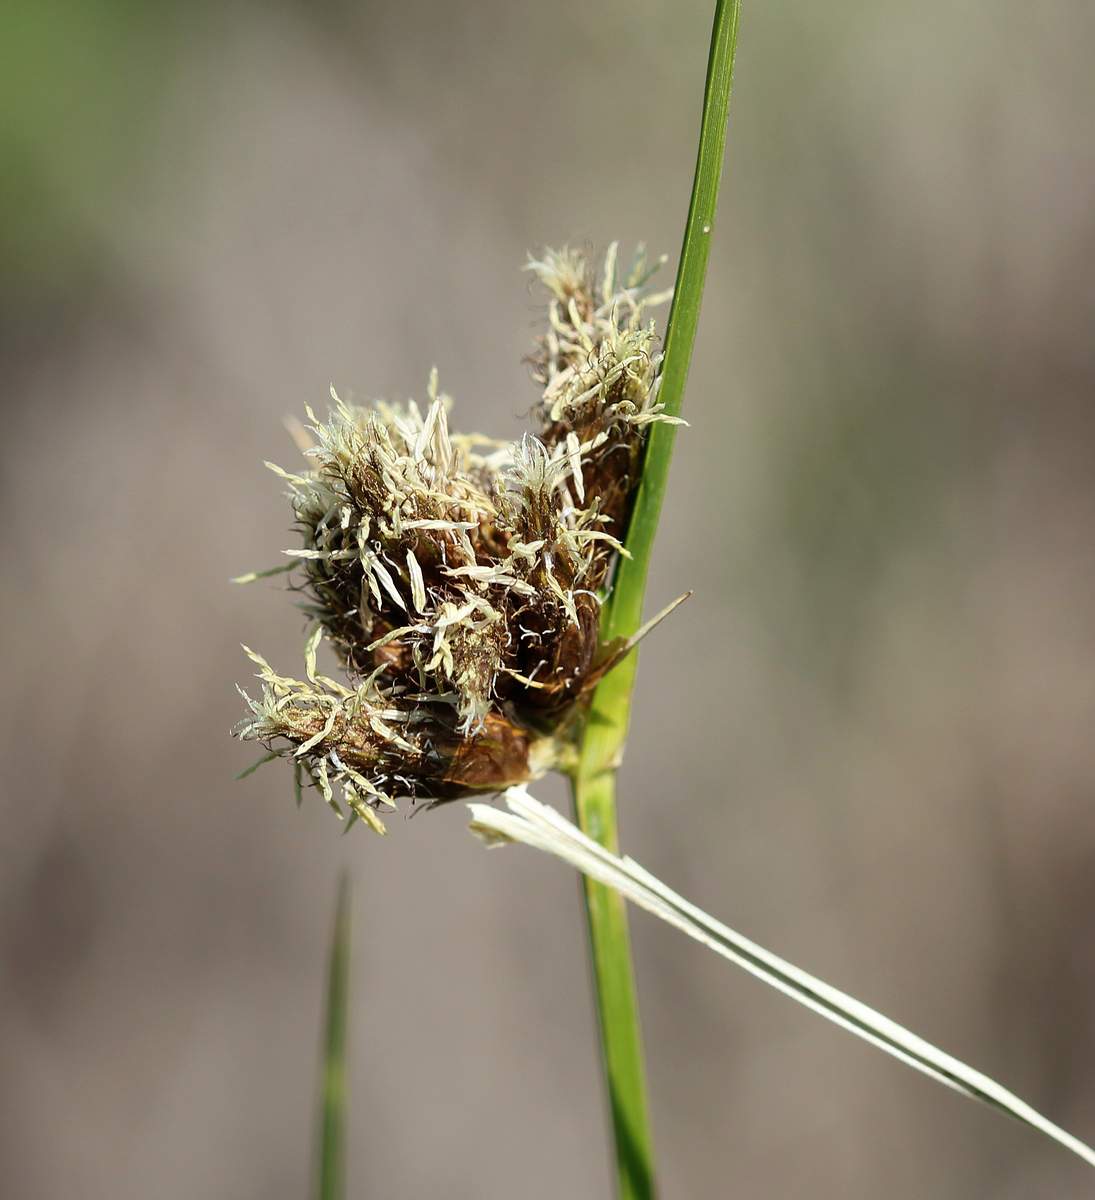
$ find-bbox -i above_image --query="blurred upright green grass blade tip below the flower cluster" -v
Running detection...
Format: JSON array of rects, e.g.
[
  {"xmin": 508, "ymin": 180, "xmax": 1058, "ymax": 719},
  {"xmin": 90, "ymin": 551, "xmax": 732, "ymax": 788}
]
[{"xmin": 315, "ymin": 875, "xmax": 351, "ymax": 1200}]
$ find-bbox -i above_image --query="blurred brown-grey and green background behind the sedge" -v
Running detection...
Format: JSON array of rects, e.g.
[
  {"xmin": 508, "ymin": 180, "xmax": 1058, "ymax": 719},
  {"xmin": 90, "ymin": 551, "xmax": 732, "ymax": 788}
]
[{"xmin": 0, "ymin": 0, "xmax": 1095, "ymax": 1200}]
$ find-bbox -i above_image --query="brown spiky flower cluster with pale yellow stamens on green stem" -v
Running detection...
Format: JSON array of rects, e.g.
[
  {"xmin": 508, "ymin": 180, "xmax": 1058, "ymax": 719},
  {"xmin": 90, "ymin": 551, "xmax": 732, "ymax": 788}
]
[{"xmin": 237, "ymin": 238, "xmax": 668, "ymax": 832}]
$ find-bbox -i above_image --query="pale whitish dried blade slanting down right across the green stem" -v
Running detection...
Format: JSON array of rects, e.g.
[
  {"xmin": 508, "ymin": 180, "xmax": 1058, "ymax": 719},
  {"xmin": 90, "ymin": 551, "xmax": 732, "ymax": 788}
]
[{"xmin": 468, "ymin": 788, "xmax": 1095, "ymax": 1166}]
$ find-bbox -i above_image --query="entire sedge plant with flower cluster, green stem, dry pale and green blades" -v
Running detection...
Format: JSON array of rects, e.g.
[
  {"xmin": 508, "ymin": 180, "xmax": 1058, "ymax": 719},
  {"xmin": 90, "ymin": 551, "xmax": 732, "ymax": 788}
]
[{"xmin": 237, "ymin": 0, "xmax": 1095, "ymax": 1200}]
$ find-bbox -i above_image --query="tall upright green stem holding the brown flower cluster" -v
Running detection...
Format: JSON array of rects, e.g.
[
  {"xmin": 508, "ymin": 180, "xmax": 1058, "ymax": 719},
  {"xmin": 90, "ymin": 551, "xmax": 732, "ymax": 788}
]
[{"xmin": 572, "ymin": 0, "xmax": 740, "ymax": 1200}]
